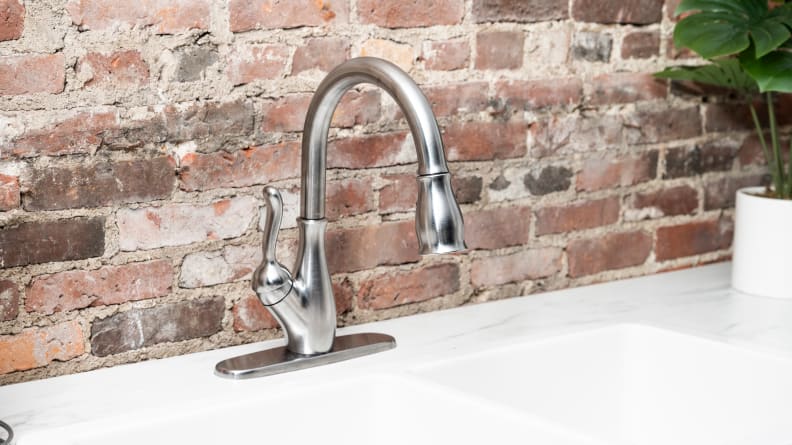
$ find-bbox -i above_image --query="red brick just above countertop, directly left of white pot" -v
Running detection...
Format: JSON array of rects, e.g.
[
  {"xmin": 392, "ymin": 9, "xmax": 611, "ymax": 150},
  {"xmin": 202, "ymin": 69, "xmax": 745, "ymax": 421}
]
[{"xmin": 655, "ymin": 219, "xmax": 734, "ymax": 261}]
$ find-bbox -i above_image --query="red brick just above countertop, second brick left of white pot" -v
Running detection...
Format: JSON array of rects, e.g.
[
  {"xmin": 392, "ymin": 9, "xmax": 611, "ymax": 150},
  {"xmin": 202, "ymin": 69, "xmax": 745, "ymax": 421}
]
[{"xmin": 567, "ymin": 231, "xmax": 652, "ymax": 278}]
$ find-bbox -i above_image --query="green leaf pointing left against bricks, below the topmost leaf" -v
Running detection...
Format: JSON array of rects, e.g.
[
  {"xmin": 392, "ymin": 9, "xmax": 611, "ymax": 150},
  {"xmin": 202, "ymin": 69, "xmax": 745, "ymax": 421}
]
[{"xmin": 655, "ymin": 59, "xmax": 757, "ymax": 93}]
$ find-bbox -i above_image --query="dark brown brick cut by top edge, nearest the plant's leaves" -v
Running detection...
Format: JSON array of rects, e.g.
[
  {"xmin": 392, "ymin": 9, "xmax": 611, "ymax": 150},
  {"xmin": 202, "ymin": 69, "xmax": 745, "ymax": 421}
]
[{"xmin": 572, "ymin": 0, "xmax": 663, "ymax": 25}]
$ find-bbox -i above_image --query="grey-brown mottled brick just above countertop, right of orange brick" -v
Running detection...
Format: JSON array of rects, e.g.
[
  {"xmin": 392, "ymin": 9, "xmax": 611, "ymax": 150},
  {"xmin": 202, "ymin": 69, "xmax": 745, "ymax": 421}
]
[{"xmin": 91, "ymin": 297, "xmax": 225, "ymax": 357}]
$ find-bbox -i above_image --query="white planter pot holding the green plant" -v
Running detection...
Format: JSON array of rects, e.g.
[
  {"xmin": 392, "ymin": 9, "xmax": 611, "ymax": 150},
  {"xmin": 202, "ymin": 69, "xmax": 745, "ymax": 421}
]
[{"xmin": 732, "ymin": 187, "xmax": 792, "ymax": 298}]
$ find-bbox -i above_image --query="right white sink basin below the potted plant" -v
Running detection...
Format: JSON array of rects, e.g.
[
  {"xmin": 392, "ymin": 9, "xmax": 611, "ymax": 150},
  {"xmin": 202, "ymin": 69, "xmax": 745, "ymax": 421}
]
[{"xmin": 416, "ymin": 324, "xmax": 792, "ymax": 445}]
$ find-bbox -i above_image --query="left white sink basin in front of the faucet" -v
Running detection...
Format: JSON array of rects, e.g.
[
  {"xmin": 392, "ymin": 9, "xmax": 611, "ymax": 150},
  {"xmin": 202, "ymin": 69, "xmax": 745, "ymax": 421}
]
[{"xmin": 18, "ymin": 375, "xmax": 588, "ymax": 445}]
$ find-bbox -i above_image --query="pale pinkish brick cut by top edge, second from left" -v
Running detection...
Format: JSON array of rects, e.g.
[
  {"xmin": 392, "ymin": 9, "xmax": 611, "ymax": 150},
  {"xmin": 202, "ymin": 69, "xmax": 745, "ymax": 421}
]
[{"xmin": 66, "ymin": 0, "xmax": 211, "ymax": 34}]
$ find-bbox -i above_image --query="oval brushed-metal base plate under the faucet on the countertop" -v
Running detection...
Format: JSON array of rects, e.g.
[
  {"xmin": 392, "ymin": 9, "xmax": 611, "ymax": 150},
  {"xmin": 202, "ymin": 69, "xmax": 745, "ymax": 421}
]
[{"xmin": 215, "ymin": 333, "xmax": 396, "ymax": 380}]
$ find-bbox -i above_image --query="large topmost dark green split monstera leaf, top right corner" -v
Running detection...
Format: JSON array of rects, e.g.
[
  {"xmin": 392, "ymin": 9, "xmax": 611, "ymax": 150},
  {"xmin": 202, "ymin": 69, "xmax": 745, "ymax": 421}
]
[{"xmin": 674, "ymin": 0, "xmax": 792, "ymax": 59}]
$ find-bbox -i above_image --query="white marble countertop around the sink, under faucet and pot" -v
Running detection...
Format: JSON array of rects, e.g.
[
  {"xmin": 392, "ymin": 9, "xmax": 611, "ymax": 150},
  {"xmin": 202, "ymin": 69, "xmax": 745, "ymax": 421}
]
[{"xmin": 0, "ymin": 263, "xmax": 792, "ymax": 438}]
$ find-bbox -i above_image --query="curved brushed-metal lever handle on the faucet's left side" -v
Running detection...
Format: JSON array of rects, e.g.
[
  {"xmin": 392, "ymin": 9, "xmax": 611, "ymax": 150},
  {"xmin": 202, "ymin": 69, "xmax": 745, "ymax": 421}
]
[{"xmin": 252, "ymin": 187, "xmax": 293, "ymax": 306}]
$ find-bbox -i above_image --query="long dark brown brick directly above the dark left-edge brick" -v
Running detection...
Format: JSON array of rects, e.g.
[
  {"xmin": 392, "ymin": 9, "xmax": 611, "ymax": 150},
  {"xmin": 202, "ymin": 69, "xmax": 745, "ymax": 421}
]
[{"xmin": 25, "ymin": 156, "xmax": 176, "ymax": 210}]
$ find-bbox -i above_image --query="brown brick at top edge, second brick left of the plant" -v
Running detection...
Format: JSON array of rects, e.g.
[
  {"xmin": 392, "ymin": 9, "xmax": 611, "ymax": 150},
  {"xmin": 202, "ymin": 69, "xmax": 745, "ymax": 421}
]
[{"xmin": 473, "ymin": 0, "xmax": 569, "ymax": 23}]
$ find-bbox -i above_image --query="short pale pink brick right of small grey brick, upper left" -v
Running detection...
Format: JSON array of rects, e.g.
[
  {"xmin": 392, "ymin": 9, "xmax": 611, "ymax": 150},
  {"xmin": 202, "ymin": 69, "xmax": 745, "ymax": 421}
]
[{"xmin": 226, "ymin": 45, "xmax": 289, "ymax": 85}]
